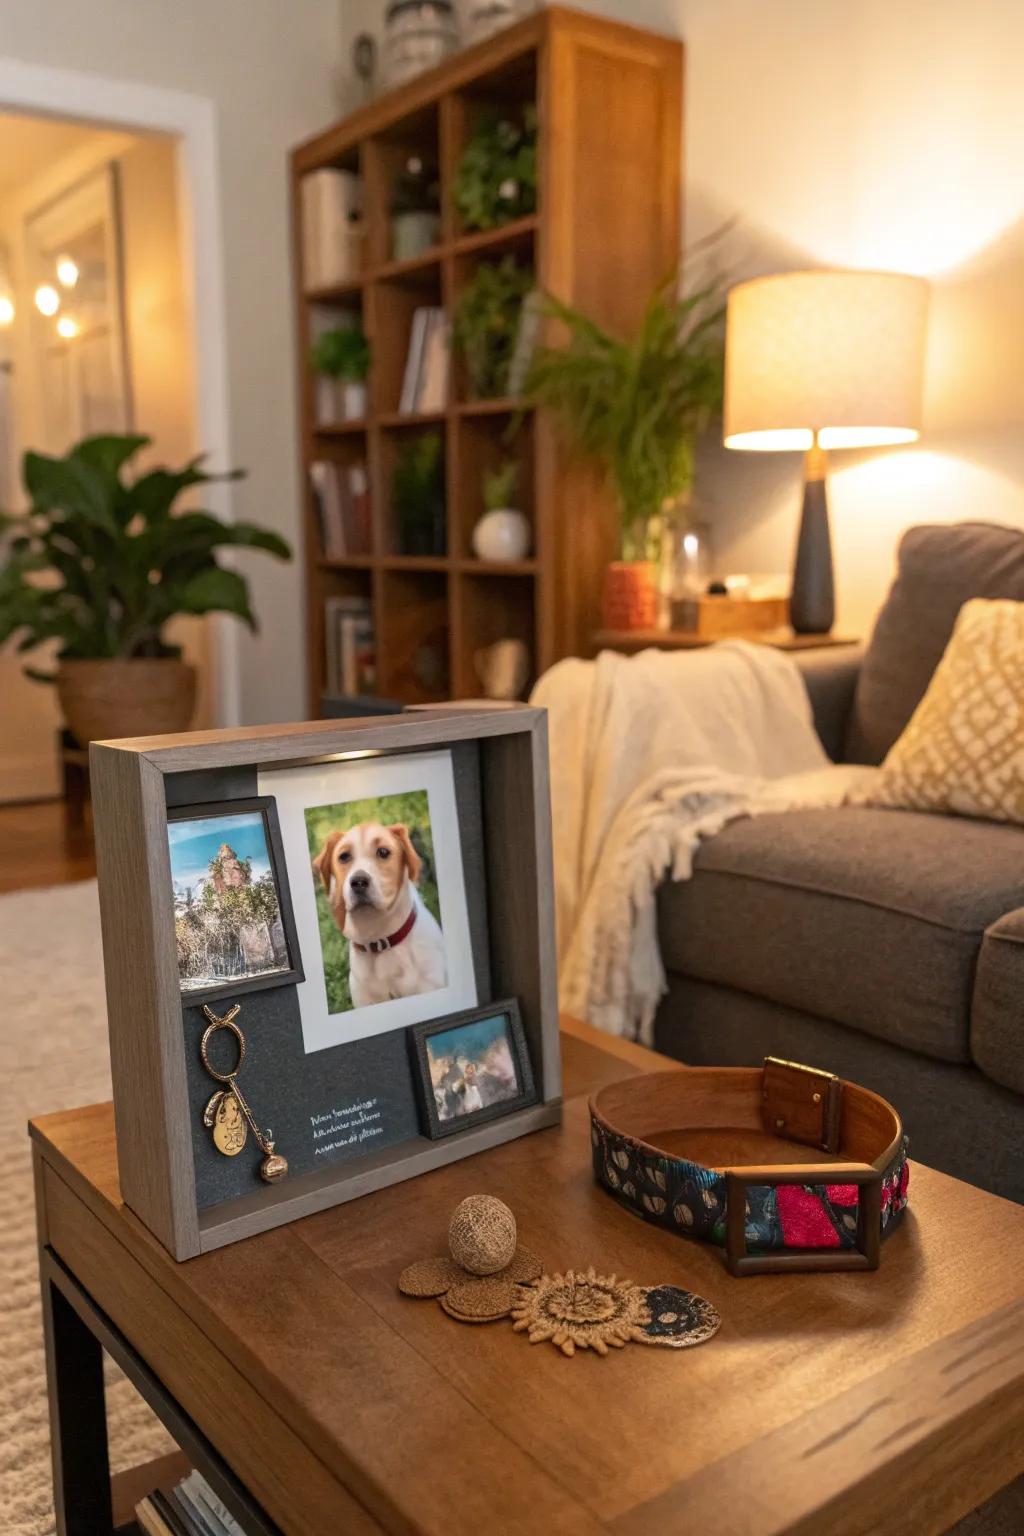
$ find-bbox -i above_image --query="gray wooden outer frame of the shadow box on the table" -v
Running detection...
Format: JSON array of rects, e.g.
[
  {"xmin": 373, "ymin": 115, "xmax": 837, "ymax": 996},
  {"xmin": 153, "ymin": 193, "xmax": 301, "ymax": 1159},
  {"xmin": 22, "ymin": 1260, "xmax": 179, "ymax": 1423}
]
[{"xmin": 89, "ymin": 705, "xmax": 562, "ymax": 1260}]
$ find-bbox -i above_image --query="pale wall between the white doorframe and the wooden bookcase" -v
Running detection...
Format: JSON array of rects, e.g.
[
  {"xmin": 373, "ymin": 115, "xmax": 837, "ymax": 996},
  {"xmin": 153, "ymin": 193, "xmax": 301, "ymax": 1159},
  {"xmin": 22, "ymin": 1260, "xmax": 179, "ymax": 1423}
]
[{"xmin": 0, "ymin": 0, "xmax": 339, "ymax": 722}]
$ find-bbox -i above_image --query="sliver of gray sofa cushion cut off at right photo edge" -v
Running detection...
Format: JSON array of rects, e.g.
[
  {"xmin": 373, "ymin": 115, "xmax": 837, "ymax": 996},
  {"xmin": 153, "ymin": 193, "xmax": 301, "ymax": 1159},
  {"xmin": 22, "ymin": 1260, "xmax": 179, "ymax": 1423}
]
[{"xmin": 970, "ymin": 908, "xmax": 1024, "ymax": 1094}]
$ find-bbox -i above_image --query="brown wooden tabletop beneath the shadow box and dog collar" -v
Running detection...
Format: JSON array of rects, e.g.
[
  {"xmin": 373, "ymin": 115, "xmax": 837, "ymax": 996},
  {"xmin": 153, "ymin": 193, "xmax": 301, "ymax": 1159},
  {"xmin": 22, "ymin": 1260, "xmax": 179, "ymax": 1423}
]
[{"xmin": 32, "ymin": 1021, "xmax": 1024, "ymax": 1536}]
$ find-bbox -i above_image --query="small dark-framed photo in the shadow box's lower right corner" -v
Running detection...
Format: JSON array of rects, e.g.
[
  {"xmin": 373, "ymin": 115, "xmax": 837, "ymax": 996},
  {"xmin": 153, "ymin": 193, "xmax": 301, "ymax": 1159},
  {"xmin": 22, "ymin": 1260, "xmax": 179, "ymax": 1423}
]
[{"xmin": 410, "ymin": 998, "xmax": 537, "ymax": 1140}]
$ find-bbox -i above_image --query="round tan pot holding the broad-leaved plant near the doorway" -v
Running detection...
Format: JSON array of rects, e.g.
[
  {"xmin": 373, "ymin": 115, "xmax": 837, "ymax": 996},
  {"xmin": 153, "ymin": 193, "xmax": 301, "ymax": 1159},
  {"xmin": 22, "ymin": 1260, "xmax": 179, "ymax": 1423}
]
[{"xmin": 57, "ymin": 656, "xmax": 195, "ymax": 745}]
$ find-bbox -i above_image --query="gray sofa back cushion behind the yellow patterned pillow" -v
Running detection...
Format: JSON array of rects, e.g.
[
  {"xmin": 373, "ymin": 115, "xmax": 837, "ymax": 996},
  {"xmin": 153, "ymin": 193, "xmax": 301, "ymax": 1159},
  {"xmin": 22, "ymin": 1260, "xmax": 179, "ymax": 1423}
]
[{"xmin": 844, "ymin": 522, "xmax": 1024, "ymax": 763}]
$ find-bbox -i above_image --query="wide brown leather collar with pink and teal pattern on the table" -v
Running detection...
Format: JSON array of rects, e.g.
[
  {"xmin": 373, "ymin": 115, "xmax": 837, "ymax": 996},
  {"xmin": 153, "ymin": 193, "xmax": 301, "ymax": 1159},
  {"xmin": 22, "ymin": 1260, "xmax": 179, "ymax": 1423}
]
[{"xmin": 590, "ymin": 1057, "xmax": 909, "ymax": 1275}]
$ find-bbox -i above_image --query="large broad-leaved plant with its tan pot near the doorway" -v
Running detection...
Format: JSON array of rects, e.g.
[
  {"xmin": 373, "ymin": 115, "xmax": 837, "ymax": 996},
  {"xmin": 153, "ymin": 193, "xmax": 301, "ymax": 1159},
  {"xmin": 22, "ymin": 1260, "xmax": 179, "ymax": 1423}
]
[{"xmin": 0, "ymin": 436, "xmax": 292, "ymax": 743}]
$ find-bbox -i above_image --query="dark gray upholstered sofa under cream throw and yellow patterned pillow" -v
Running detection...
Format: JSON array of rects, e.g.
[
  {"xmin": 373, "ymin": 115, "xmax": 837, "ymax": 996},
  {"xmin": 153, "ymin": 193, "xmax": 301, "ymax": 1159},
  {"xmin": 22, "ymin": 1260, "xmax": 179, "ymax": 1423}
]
[{"xmin": 656, "ymin": 524, "xmax": 1024, "ymax": 1201}]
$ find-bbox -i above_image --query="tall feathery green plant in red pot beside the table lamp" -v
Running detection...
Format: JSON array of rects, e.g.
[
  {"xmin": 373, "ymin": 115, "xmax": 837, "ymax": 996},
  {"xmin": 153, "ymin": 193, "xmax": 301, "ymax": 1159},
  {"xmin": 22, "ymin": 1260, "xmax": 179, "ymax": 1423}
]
[{"xmin": 525, "ymin": 278, "xmax": 725, "ymax": 630}]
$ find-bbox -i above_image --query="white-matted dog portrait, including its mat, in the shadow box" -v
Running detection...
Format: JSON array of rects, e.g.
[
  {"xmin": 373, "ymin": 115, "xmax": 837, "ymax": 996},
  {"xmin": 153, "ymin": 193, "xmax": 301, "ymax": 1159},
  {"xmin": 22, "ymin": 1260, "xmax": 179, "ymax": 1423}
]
[{"xmin": 259, "ymin": 750, "xmax": 477, "ymax": 1051}]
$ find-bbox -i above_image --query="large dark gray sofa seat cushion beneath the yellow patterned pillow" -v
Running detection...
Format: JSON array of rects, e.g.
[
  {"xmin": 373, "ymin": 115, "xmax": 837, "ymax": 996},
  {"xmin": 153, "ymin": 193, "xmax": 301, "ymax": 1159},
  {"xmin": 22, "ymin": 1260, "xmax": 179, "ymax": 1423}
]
[{"xmin": 659, "ymin": 806, "xmax": 1024, "ymax": 1061}]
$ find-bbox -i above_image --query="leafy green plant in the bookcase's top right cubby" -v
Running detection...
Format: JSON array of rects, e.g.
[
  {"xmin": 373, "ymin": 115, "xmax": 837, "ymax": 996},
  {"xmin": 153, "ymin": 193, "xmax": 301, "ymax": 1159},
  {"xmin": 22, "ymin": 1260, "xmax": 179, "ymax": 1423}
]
[{"xmin": 454, "ymin": 106, "xmax": 537, "ymax": 229}]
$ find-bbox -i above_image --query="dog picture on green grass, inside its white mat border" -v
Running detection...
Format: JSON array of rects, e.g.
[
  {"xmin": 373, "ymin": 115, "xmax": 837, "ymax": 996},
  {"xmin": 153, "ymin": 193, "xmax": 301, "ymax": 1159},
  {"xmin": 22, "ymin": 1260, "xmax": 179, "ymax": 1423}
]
[{"xmin": 304, "ymin": 790, "xmax": 448, "ymax": 1014}]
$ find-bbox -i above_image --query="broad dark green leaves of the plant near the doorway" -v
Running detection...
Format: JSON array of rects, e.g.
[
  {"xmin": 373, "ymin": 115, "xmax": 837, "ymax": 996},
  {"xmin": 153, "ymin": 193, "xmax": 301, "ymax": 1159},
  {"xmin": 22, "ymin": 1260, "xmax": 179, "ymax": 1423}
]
[{"xmin": 0, "ymin": 436, "xmax": 292, "ymax": 682}]
